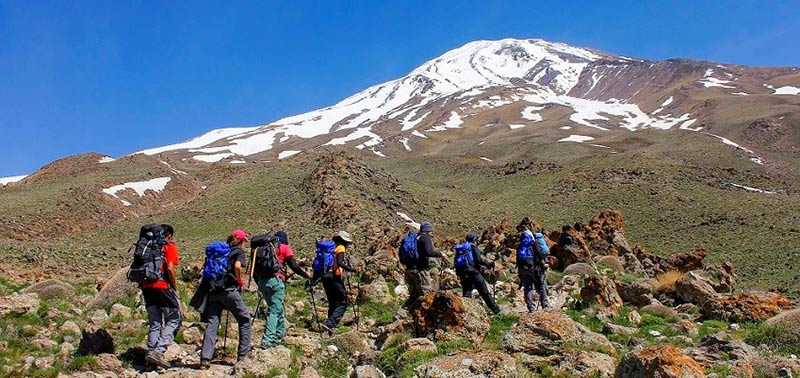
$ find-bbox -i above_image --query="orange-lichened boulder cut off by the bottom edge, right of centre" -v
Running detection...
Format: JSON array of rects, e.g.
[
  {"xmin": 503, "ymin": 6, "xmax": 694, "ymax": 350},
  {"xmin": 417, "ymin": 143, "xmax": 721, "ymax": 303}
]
[{"xmin": 615, "ymin": 345, "xmax": 706, "ymax": 378}]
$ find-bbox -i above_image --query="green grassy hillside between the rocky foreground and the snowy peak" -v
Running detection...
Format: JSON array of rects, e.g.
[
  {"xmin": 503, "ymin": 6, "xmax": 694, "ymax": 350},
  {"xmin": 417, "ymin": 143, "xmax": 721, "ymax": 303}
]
[{"xmin": 0, "ymin": 131, "xmax": 800, "ymax": 295}]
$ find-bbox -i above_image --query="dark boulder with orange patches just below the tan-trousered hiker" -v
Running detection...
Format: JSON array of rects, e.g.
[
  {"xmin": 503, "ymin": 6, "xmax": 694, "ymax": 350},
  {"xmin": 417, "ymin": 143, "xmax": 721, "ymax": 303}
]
[{"xmin": 409, "ymin": 290, "xmax": 489, "ymax": 345}]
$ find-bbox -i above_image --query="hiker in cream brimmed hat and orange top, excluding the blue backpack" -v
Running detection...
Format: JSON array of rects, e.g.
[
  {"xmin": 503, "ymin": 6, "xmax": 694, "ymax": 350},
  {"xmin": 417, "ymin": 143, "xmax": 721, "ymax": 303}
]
[{"xmin": 321, "ymin": 231, "xmax": 357, "ymax": 333}]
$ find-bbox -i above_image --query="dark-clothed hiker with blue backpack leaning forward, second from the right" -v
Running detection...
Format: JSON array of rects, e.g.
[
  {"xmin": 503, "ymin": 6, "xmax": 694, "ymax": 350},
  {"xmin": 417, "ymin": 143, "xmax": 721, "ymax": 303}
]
[{"xmin": 453, "ymin": 234, "xmax": 500, "ymax": 314}]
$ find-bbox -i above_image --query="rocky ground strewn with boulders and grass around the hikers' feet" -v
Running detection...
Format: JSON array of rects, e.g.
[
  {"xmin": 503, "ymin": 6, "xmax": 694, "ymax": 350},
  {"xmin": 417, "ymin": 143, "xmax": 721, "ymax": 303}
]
[{"xmin": 0, "ymin": 210, "xmax": 800, "ymax": 377}]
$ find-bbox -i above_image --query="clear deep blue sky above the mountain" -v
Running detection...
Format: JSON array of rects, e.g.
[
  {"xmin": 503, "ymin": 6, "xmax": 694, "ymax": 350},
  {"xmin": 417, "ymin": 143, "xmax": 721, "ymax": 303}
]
[{"xmin": 0, "ymin": 0, "xmax": 800, "ymax": 176}]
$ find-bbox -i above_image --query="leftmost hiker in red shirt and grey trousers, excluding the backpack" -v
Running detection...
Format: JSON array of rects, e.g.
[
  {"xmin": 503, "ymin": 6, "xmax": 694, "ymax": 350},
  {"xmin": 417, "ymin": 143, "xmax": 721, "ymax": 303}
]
[{"xmin": 141, "ymin": 224, "xmax": 181, "ymax": 369}]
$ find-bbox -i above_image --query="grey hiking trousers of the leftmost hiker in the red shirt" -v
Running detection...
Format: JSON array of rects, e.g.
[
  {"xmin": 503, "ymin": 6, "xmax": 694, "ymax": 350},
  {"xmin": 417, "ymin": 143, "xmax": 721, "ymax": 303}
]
[{"xmin": 142, "ymin": 289, "xmax": 181, "ymax": 354}]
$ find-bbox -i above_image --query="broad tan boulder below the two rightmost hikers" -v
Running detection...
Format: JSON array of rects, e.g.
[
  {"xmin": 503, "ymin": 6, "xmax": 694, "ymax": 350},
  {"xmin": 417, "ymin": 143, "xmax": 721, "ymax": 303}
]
[{"xmin": 503, "ymin": 311, "xmax": 616, "ymax": 355}]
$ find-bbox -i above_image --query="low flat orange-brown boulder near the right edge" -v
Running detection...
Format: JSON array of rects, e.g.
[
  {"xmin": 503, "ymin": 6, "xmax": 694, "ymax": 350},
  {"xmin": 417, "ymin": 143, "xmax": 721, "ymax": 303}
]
[{"xmin": 702, "ymin": 291, "xmax": 792, "ymax": 323}]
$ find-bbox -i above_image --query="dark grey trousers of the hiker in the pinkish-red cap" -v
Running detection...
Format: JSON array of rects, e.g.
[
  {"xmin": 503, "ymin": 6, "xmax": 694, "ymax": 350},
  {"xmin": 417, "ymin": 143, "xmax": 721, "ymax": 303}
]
[{"xmin": 200, "ymin": 290, "xmax": 252, "ymax": 361}]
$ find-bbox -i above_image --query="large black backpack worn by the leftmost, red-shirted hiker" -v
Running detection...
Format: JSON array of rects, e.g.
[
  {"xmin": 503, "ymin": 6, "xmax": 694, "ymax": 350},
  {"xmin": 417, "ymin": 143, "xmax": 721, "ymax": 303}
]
[{"xmin": 128, "ymin": 224, "xmax": 167, "ymax": 286}]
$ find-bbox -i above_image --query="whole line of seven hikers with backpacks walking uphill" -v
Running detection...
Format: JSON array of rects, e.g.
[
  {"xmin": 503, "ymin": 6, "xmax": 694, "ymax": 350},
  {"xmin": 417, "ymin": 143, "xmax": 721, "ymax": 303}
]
[{"xmin": 128, "ymin": 222, "xmax": 549, "ymax": 369}]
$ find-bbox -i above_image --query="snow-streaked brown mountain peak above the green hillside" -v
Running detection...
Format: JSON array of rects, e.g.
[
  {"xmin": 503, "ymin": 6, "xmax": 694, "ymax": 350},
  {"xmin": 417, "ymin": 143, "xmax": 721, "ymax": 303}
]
[{"xmin": 139, "ymin": 39, "xmax": 800, "ymax": 163}]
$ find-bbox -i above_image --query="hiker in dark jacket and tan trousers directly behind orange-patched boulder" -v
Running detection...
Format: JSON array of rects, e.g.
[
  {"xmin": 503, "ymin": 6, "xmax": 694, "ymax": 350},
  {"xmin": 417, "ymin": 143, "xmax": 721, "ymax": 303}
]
[{"xmin": 400, "ymin": 222, "xmax": 442, "ymax": 308}]
